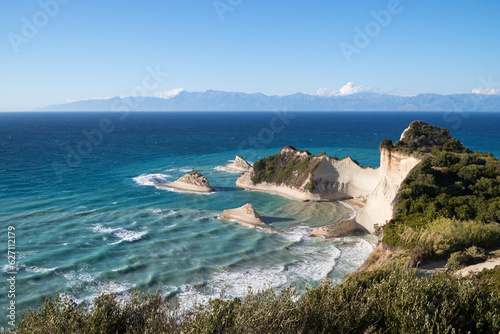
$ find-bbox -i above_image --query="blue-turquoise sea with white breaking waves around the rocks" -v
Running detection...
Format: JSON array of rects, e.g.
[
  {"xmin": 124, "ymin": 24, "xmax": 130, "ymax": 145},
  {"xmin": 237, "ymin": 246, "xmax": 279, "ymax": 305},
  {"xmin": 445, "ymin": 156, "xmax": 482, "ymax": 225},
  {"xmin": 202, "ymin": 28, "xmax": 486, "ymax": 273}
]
[{"xmin": 0, "ymin": 111, "xmax": 500, "ymax": 326}]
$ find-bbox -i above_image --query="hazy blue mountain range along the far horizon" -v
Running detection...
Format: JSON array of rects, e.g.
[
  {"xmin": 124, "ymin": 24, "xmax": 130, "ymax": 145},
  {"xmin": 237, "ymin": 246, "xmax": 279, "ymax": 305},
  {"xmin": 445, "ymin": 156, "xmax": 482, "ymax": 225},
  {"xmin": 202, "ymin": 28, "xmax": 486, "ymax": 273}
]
[{"xmin": 36, "ymin": 90, "xmax": 500, "ymax": 111}]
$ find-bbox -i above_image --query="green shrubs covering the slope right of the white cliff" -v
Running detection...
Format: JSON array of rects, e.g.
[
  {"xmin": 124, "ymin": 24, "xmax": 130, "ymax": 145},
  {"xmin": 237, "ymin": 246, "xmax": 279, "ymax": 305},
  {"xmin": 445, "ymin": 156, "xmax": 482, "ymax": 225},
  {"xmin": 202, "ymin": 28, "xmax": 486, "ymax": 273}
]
[{"xmin": 384, "ymin": 152, "xmax": 500, "ymax": 257}]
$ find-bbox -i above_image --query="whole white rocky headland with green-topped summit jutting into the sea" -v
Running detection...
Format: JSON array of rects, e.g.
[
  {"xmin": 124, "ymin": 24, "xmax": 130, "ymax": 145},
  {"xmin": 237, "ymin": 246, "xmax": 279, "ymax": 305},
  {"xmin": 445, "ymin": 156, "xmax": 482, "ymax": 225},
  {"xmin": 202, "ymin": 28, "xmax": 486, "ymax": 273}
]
[{"xmin": 236, "ymin": 121, "xmax": 467, "ymax": 237}]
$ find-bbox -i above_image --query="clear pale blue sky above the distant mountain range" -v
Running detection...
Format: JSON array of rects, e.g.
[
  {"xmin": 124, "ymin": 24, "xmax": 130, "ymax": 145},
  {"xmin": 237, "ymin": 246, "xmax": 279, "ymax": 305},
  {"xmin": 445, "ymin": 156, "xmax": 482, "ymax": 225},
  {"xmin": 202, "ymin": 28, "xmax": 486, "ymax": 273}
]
[{"xmin": 0, "ymin": 0, "xmax": 500, "ymax": 111}]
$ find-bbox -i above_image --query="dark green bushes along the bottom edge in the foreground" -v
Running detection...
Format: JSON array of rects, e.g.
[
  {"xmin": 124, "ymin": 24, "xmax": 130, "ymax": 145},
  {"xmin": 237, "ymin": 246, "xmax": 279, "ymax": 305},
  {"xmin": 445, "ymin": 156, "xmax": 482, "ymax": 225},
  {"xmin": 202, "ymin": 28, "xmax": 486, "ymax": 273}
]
[{"xmin": 6, "ymin": 269, "xmax": 500, "ymax": 334}]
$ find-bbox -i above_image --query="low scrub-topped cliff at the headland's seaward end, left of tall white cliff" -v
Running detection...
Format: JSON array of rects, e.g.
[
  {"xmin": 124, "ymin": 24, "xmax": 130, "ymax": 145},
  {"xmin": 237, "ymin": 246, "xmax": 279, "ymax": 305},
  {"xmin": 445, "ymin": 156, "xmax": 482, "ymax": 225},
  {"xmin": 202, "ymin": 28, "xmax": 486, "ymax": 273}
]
[{"xmin": 236, "ymin": 146, "xmax": 379, "ymax": 201}]
